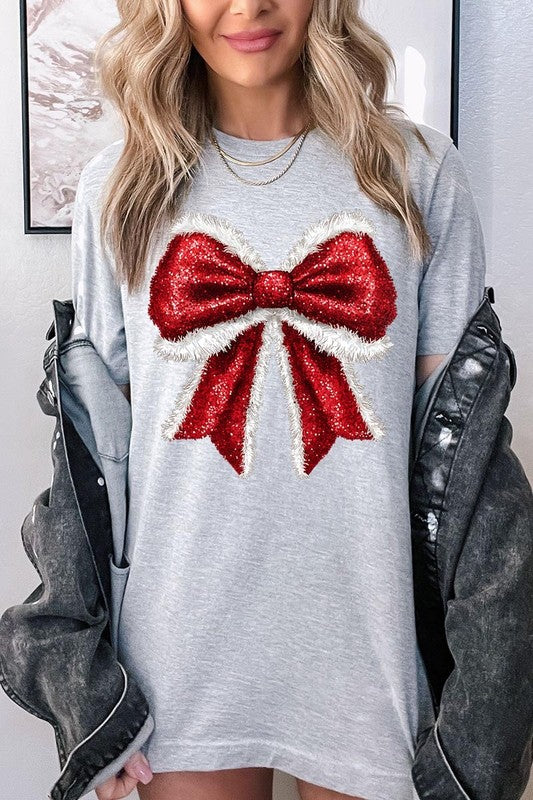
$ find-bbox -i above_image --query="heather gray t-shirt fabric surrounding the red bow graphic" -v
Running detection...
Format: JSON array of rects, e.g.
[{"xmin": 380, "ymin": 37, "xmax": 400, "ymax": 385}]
[{"xmin": 72, "ymin": 120, "xmax": 485, "ymax": 800}]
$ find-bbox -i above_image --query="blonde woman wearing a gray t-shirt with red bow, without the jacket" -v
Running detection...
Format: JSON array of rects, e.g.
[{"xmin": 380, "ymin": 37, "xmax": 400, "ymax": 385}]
[{"xmin": 72, "ymin": 0, "xmax": 485, "ymax": 800}]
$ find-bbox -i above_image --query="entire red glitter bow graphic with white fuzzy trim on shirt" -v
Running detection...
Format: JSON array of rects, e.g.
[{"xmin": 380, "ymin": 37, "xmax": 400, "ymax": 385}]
[{"xmin": 148, "ymin": 211, "xmax": 396, "ymax": 477}]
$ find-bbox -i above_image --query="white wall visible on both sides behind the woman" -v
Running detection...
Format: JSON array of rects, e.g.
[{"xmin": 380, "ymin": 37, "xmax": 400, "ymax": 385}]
[{"xmin": 0, "ymin": 0, "xmax": 533, "ymax": 800}]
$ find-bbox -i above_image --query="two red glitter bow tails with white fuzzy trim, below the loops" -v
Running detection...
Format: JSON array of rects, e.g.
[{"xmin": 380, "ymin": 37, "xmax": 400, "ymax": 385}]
[{"xmin": 163, "ymin": 321, "xmax": 383, "ymax": 475}]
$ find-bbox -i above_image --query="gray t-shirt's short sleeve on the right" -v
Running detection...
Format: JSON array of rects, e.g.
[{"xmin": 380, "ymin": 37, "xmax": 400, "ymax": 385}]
[{"xmin": 417, "ymin": 142, "xmax": 486, "ymax": 355}]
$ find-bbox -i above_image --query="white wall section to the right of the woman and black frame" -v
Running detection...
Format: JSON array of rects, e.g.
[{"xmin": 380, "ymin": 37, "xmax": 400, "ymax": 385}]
[{"xmin": 459, "ymin": 0, "xmax": 533, "ymax": 476}]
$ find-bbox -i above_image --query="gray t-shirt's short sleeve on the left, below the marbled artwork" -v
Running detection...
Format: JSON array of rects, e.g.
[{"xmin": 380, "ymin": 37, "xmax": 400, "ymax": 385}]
[{"xmin": 71, "ymin": 162, "xmax": 129, "ymax": 384}]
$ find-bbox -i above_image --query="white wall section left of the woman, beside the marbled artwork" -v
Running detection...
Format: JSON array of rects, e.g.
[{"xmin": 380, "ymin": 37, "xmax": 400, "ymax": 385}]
[{"xmin": 0, "ymin": 3, "xmax": 69, "ymax": 800}]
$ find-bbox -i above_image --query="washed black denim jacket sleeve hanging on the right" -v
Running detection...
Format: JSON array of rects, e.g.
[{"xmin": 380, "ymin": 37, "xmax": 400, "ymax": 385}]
[{"xmin": 413, "ymin": 416, "xmax": 533, "ymax": 800}]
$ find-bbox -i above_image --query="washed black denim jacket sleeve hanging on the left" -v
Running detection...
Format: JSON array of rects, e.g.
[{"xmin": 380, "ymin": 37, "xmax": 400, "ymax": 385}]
[{"xmin": 0, "ymin": 322, "xmax": 153, "ymax": 800}]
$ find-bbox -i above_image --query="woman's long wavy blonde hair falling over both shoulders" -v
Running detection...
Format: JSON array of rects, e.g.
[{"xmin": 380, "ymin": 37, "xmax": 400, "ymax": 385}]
[{"xmin": 95, "ymin": 0, "xmax": 431, "ymax": 292}]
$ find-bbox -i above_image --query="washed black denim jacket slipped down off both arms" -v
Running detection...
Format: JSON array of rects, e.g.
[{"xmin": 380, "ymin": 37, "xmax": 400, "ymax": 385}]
[{"xmin": 0, "ymin": 287, "xmax": 533, "ymax": 800}]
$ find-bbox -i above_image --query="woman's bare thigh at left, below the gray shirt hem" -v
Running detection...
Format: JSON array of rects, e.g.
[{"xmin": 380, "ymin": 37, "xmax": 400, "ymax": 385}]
[{"xmin": 137, "ymin": 767, "xmax": 273, "ymax": 800}]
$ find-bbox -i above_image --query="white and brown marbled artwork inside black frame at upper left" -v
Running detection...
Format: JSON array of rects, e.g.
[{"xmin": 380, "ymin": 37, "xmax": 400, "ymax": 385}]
[{"xmin": 25, "ymin": 0, "xmax": 122, "ymax": 228}]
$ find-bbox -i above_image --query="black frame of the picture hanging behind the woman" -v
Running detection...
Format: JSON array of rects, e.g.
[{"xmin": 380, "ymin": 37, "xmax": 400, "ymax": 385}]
[{"xmin": 19, "ymin": 0, "xmax": 461, "ymax": 234}]
